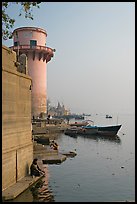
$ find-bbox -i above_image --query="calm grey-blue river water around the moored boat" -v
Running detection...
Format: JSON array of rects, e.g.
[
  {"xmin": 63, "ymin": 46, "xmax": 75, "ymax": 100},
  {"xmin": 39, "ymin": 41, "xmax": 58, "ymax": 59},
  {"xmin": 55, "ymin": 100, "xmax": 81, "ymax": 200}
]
[{"xmin": 8, "ymin": 114, "xmax": 135, "ymax": 202}]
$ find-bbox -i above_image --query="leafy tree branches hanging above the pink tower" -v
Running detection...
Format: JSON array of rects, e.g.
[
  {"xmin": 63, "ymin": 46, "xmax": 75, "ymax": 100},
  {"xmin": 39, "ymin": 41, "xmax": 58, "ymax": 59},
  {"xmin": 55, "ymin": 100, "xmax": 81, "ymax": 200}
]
[{"xmin": 2, "ymin": 2, "xmax": 41, "ymax": 40}]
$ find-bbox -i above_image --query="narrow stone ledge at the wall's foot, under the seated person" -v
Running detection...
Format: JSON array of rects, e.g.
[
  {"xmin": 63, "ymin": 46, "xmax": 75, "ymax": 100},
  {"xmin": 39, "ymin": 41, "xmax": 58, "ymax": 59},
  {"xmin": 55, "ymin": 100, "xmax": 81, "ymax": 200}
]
[{"xmin": 2, "ymin": 175, "xmax": 43, "ymax": 201}]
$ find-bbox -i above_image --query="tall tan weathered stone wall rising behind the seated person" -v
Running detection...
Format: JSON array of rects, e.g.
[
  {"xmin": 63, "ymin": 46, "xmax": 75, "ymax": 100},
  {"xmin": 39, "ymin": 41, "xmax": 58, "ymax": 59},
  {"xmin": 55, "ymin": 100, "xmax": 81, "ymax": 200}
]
[{"xmin": 2, "ymin": 46, "xmax": 33, "ymax": 190}]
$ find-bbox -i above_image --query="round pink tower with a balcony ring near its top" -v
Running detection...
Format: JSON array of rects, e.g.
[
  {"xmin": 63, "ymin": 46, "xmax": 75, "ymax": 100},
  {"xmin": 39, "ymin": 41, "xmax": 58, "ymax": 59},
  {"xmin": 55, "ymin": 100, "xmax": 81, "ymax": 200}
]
[{"xmin": 11, "ymin": 27, "xmax": 55, "ymax": 117}]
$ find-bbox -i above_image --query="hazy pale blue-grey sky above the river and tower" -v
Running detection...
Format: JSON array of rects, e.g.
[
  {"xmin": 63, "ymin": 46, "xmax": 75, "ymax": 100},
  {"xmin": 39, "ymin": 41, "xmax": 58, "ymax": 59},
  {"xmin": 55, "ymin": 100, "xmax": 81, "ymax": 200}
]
[{"xmin": 3, "ymin": 2, "xmax": 135, "ymax": 114}]
